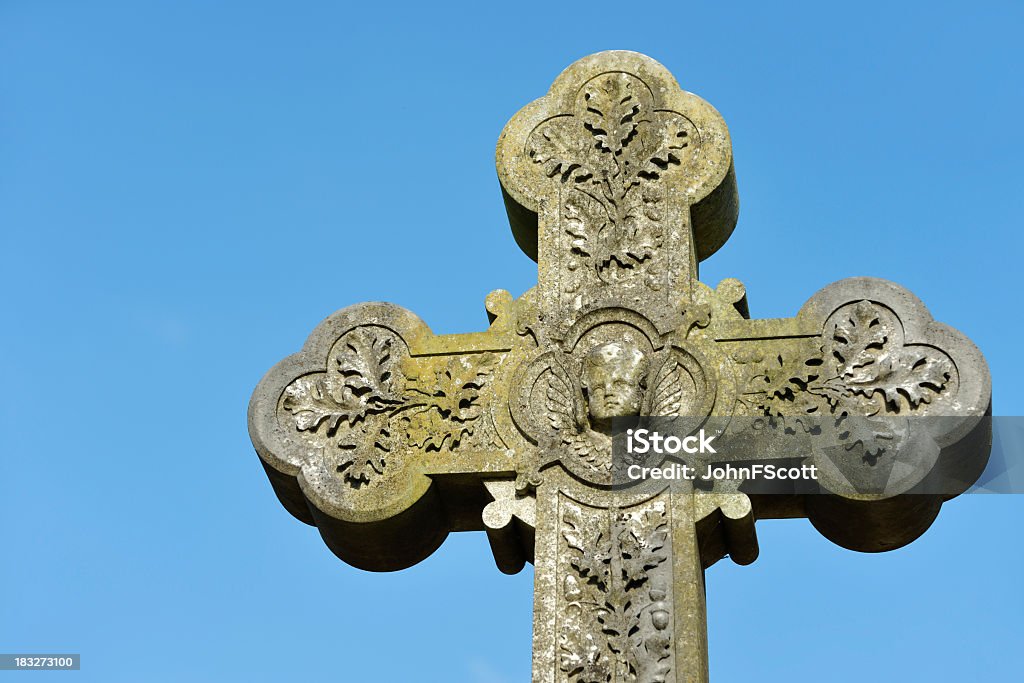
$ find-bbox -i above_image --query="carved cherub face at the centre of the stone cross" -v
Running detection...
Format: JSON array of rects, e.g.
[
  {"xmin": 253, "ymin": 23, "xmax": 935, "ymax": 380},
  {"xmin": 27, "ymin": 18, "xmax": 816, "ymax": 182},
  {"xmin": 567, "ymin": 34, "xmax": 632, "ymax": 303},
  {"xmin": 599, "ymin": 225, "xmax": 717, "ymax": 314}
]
[{"xmin": 583, "ymin": 342, "xmax": 650, "ymax": 423}]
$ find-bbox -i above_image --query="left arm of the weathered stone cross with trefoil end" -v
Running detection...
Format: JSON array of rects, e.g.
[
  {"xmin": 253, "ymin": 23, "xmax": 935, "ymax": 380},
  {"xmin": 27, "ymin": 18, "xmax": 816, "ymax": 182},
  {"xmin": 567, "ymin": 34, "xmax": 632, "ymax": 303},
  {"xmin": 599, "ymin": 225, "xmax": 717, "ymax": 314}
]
[{"xmin": 249, "ymin": 291, "xmax": 532, "ymax": 570}]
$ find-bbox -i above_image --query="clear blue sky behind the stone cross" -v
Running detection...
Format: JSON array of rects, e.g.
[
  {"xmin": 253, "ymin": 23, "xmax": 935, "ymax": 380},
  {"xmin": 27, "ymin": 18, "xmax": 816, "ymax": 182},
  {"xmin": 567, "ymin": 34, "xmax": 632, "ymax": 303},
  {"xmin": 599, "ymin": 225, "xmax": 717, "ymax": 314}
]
[{"xmin": 0, "ymin": 0, "xmax": 1024, "ymax": 683}]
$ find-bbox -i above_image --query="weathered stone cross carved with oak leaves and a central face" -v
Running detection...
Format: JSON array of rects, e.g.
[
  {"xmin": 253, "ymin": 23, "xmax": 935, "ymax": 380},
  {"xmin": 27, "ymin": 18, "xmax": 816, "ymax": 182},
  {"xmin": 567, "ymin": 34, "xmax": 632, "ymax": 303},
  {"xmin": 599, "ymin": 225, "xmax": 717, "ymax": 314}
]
[{"xmin": 249, "ymin": 51, "xmax": 990, "ymax": 683}]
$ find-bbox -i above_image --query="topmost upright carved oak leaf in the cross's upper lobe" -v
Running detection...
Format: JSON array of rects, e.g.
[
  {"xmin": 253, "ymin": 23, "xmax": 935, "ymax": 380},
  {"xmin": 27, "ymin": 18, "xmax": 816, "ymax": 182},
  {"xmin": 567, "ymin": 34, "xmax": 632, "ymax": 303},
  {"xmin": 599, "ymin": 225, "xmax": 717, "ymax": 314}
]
[{"xmin": 583, "ymin": 74, "xmax": 642, "ymax": 154}]
